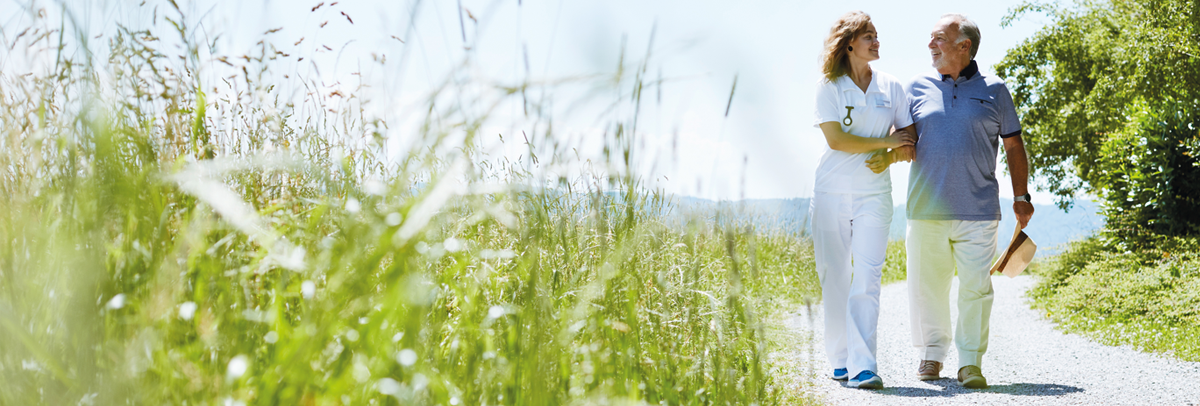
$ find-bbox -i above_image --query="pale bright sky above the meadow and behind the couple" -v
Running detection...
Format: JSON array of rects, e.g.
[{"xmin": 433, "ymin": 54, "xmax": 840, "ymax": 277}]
[{"xmin": 0, "ymin": 0, "xmax": 1051, "ymax": 203}]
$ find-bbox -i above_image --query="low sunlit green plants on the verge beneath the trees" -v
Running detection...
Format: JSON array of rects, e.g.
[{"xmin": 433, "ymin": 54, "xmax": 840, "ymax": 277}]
[{"xmin": 1030, "ymin": 237, "xmax": 1200, "ymax": 362}]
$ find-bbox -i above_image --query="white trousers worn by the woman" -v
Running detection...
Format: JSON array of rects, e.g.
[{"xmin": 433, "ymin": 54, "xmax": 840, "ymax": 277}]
[{"xmin": 811, "ymin": 192, "xmax": 892, "ymax": 377}]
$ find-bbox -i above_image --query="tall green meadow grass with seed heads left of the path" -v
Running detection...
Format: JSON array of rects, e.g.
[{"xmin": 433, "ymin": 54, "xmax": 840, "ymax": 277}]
[{"xmin": 0, "ymin": 2, "xmax": 817, "ymax": 405}]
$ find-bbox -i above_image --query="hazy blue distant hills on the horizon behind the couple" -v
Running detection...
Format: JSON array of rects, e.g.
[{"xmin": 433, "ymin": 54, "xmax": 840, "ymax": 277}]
[{"xmin": 674, "ymin": 196, "xmax": 1104, "ymax": 255}]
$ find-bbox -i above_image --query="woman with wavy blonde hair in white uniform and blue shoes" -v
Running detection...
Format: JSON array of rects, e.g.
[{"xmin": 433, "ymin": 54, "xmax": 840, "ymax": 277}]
[{"xmin": 811, "ymin": 11, "xmax": 913, "ymax": 389}]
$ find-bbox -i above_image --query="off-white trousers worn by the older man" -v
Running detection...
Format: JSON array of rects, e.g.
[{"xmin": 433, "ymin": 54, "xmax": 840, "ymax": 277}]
[{"xmin": 906, "ymin": 220, "xmax": 1000, "ymax": 368}]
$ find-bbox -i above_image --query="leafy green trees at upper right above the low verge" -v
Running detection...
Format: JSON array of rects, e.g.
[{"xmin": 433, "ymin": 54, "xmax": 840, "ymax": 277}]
[{"xmin": 996, "ymin": 0, "xmax": 1200, "ymax": 224}]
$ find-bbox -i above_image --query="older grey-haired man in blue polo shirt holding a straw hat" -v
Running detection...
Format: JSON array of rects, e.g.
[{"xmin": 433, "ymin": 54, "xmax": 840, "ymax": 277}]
[{"xmin": 869, "ymin": 14, "xmax": 1033, "ymax": 388}]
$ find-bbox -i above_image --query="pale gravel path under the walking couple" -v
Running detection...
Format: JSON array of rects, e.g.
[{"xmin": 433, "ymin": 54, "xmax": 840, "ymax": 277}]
[{"xmin": 788, "ymin": 275, "xmax": 1200, "ymax": 405}]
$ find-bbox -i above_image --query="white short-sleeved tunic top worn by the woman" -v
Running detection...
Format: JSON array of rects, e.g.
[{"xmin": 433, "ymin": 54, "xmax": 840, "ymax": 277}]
[{"xmin": 812, "ymin": 70, "xmax": 912, "ymax": 195}]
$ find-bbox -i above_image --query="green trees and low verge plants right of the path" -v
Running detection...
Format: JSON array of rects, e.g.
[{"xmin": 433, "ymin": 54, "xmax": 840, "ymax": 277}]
[{"xmin": 996, "ymin": 0, "xmax": 1200, "ymax": 360}]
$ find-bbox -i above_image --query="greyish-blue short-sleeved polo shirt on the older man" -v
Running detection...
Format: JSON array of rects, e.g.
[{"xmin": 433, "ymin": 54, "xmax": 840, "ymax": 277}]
[{"xmin": 906, "ymin": 60, "xmax": 1021, "ymax": 221}]
